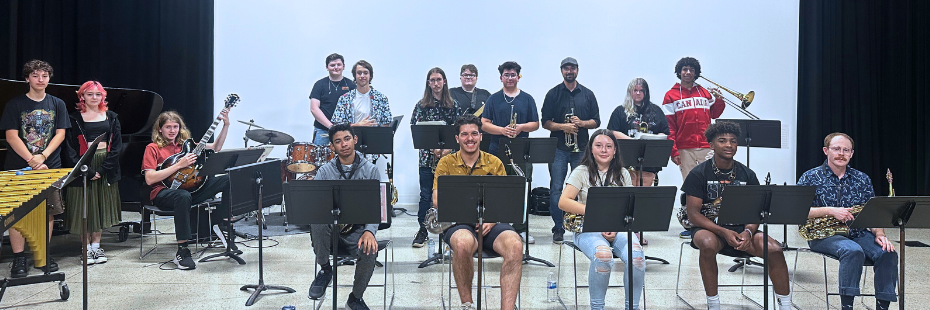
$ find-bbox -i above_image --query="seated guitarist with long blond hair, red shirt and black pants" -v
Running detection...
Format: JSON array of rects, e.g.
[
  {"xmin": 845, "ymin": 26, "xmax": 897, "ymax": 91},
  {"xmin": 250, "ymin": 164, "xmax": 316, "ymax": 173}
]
[{"xmin": 142, "ymin": 110, "xmax": 238, "ymax": 270}]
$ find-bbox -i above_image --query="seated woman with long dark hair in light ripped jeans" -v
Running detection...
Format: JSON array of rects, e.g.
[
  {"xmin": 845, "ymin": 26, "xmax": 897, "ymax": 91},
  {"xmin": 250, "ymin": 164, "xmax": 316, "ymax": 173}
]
[{"xmin": 559, "ymin": 129, "xmax": 646, "ymax": 310}]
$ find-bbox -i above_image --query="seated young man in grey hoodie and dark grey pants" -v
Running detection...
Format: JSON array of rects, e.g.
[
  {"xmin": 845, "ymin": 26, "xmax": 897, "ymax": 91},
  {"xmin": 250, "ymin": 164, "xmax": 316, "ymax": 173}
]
[{"xmin": 308, "ymin": 123, "xmax": 381, "ymax": 310}]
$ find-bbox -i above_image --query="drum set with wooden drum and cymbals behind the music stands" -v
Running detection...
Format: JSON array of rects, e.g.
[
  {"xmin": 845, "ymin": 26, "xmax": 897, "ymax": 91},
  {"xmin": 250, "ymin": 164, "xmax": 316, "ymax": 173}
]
[{"xmin": 239, "ymin": 120, "xmax": 335, "ymax": 182}]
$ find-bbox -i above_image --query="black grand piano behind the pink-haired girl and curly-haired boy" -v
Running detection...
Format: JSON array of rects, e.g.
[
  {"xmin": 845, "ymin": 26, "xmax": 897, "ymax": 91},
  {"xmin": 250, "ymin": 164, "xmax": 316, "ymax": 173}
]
[{"xmin": 0, "ymin": 79, "xmax": 164, "ymax": 220}]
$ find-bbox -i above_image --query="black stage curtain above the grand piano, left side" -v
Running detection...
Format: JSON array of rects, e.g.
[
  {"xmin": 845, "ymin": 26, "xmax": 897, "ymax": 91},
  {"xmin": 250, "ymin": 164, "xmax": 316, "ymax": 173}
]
[{"xmin": 0, "ymin": 0, "xmax": 214, "ymax": 139}]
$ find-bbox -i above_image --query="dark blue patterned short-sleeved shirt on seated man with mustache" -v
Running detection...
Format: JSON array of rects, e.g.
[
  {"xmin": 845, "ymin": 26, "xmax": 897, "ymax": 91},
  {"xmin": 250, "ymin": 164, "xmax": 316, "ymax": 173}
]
[{"xmin": 798, "ymin": 161, "xmax": 875, "ymax": 237}]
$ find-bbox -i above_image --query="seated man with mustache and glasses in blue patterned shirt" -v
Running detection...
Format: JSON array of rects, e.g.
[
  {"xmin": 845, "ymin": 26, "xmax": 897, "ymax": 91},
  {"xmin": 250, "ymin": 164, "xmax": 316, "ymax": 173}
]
[{"xmin": 798, "ymin": 132, "xmax": 898, "ymax": 310}]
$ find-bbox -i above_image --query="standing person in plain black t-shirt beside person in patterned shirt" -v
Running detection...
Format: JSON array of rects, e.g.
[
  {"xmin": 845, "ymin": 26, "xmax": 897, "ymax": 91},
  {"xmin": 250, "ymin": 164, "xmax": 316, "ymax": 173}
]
[{"xmin": 310, "ymin": 53, "xmax": 355, "ymax": 146}]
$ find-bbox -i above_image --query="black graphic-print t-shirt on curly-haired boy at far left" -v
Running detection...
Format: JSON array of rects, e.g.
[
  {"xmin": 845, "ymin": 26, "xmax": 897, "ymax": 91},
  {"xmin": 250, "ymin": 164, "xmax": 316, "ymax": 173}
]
[{"xmin": 0, "ymin": 94, "xmax": 71, "ymax": 170}]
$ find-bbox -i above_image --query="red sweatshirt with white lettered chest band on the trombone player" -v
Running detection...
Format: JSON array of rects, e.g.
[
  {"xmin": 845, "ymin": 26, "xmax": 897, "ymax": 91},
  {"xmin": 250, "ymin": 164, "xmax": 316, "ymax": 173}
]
[{"xmin": 662, "ymin": 83, "xmax": 726, "ymax": 157}]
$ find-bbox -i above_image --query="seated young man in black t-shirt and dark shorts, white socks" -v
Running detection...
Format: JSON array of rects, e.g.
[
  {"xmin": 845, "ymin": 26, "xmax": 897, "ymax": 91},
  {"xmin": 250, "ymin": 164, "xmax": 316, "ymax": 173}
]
[{"xmin": 681, "ymin": 121, "xmax": 791, "ymax": 310}]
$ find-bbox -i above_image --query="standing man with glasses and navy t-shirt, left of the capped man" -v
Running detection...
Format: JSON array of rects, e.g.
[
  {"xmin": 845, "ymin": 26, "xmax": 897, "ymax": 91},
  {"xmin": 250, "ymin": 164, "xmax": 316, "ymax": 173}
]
[{"xmin": 481, "ymin": 61, "xmax": 539, "ymax": 243}]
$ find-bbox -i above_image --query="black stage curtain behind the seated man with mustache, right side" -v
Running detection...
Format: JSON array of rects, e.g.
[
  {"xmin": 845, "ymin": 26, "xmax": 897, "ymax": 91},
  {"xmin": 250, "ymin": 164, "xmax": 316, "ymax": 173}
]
[{"xmin": 797, "ymin": 0, "xmax": 930, "ymax": 195}]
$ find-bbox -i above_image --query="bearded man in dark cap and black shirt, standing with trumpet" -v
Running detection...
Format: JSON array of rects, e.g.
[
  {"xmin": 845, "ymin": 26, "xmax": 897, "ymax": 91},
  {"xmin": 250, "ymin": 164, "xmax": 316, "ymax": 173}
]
[{"xmin": 541, "ymin": 57, "xmax": 601, "ymax": 243}]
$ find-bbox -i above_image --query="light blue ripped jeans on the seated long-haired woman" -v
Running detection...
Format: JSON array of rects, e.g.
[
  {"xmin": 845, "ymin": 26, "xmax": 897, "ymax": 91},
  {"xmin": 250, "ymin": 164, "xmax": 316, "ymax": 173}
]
[{"xmin": 575, "ymin": 233, "xmax": 646, "ymax": 310}]
